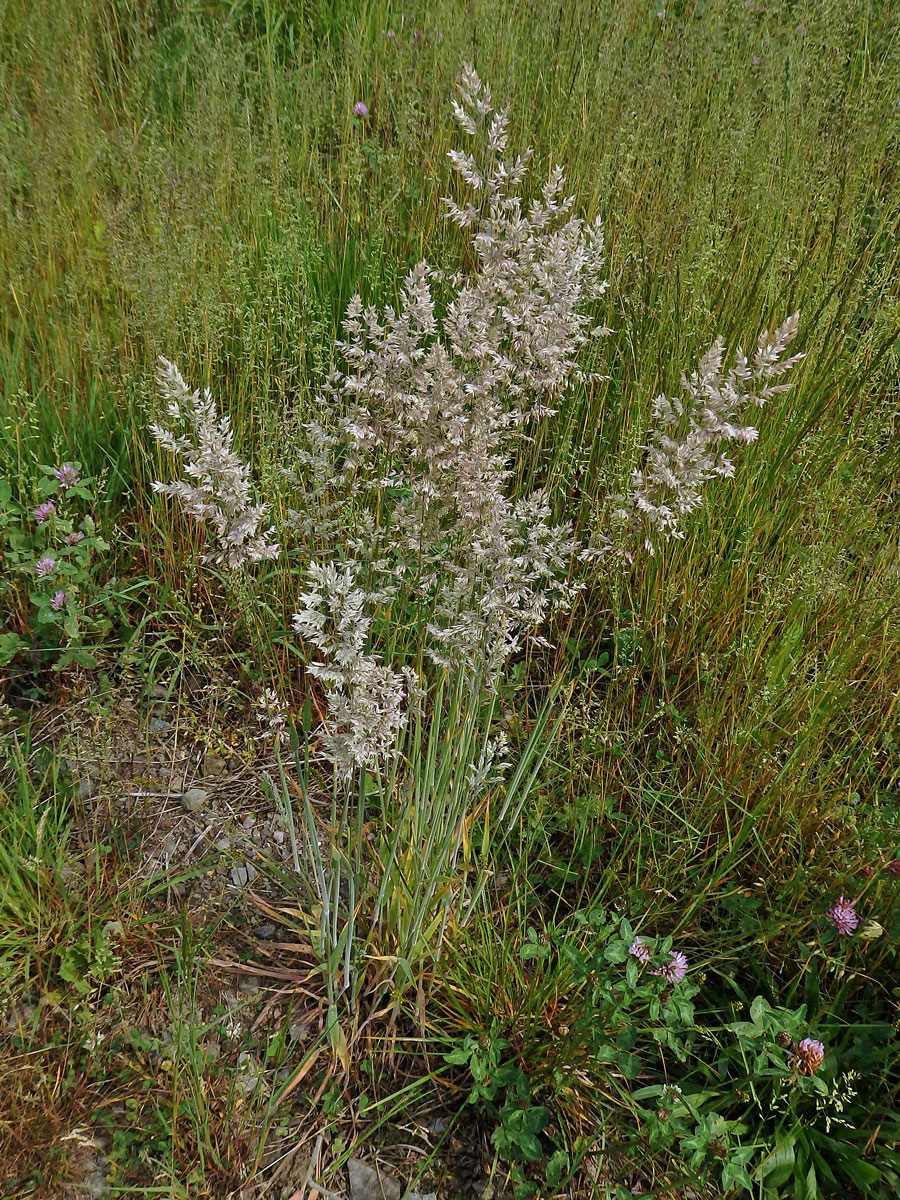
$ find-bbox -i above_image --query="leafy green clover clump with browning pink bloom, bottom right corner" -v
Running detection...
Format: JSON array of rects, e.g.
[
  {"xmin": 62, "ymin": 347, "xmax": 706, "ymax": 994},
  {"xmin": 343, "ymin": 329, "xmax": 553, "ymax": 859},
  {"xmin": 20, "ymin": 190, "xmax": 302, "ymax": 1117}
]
[{"xmin": 634, "ymin": 996, "xmax": 900, "ymax": 1198}]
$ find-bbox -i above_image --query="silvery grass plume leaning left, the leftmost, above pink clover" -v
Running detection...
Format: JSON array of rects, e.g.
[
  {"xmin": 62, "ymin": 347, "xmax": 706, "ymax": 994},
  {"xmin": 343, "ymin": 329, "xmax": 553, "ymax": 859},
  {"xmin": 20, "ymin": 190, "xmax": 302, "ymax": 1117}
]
[{"xmin": 150, "ymin": 358, "xmax": 278, "ymax": 569}]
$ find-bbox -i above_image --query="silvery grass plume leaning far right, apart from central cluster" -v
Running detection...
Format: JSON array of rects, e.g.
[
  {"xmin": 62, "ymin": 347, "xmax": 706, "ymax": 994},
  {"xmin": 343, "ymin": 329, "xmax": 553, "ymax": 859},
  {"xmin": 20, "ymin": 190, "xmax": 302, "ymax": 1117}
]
[{"xmin": 617, "ymin": 313, "xmax": 803, "ymax": 553}]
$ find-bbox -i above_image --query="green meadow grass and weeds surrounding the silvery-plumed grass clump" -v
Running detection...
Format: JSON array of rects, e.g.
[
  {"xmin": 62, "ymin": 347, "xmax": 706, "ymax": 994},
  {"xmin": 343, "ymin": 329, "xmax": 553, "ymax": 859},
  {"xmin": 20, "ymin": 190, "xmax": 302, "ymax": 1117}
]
[{"xmin": 0, "ymin": 0, "xmax": 900, "ymax": 1198}]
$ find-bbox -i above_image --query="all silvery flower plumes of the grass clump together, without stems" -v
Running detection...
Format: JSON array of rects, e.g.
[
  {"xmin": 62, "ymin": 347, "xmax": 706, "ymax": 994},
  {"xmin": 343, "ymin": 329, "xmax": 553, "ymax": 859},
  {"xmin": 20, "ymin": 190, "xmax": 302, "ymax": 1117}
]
[{"xmin": 152, "ymin": 66, "xmax": 802, "ymax": 766}]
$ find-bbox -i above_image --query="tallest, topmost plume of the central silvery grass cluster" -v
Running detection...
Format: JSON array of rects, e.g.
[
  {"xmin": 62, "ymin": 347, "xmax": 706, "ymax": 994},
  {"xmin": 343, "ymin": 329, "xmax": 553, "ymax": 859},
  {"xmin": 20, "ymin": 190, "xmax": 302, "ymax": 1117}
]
[{"xmin": 444, "ymin": 65, "xmax": 608, "ymax": 421}]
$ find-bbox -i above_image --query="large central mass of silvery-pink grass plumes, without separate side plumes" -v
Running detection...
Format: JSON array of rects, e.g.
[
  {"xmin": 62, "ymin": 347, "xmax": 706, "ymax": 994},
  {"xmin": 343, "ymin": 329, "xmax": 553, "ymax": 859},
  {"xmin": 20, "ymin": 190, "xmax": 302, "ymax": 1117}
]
[{"xmin": 293, "ymin": 67, "xmax": 607, "ymax": 683}]
